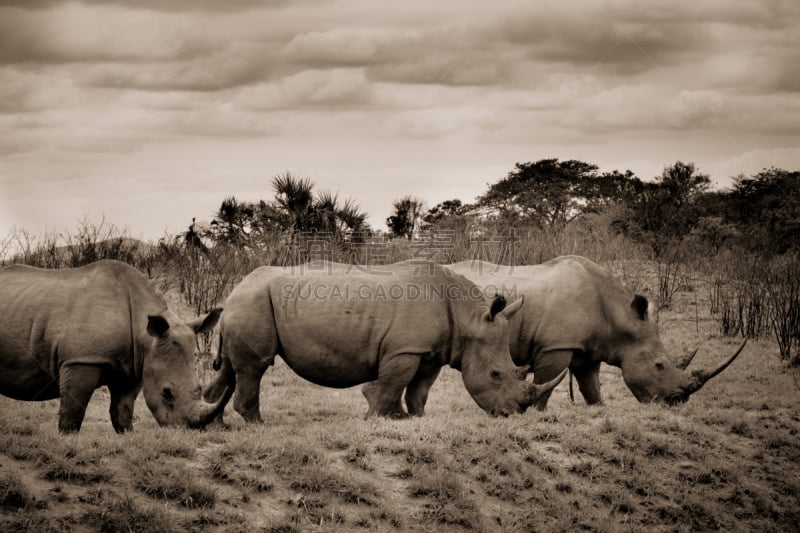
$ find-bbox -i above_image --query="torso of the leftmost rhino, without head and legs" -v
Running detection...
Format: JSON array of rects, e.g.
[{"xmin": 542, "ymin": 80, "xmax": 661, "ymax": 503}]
[{"xmin": 0, "ymin": 261, "xmax": 166, "ymax": 396}]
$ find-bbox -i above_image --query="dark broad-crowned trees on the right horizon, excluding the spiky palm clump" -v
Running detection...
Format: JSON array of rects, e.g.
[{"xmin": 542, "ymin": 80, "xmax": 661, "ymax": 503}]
[{"xmin": 387, "ymin": 159, "xmax": 800, "ymax": 255}]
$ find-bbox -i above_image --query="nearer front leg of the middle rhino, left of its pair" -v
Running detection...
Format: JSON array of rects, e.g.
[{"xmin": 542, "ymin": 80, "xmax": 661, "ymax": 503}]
[{"xmin": 364, "ymin": 354, "xmax": 420, "ymax": 418}]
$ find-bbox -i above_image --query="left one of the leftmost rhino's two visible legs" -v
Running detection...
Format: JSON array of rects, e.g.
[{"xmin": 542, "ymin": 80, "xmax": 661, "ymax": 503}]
[{"xmin": 58, "ymin": 364, "xmax": 103, "ymax": 433}]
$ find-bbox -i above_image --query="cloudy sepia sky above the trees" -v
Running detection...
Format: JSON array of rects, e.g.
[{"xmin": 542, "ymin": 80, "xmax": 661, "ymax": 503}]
[{"xmin": 0, "ymin": 0, "xmax": 800, "ymax": 240}]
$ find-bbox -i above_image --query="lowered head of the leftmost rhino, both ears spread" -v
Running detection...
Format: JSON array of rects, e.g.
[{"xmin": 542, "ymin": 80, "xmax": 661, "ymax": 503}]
[{"xmin": 142, "ymin": 309, "xmax": 233, "ymax": 428}]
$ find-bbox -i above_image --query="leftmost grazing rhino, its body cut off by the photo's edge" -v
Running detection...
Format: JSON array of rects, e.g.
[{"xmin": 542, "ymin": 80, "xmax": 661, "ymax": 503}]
[{"xmin": 0, "ymin": 260, "xmax": 233, "ymax": 433}]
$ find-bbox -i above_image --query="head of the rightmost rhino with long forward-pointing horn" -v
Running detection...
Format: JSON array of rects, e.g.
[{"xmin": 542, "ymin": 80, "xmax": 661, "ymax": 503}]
[{"xmin": 617, "ymin": 295, "xmax": 747, "ymax": 405}]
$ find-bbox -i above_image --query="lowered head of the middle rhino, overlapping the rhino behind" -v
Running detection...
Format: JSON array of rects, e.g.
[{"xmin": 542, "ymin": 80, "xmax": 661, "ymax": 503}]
[{"xmin": 461, "ymin": 295, "xmax": 567, "ymax": 416}]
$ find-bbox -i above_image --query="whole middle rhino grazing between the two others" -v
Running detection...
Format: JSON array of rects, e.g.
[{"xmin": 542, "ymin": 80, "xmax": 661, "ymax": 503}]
[{"xmin": 205, "ymin": 261, "xmax": 566, "ymax": 422}]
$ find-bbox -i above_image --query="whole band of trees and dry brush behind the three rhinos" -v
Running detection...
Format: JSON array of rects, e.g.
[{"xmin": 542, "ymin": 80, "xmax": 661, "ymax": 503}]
[{"xmin": 6, "ymin": 159, "xmax": 800, "ymax": 366}]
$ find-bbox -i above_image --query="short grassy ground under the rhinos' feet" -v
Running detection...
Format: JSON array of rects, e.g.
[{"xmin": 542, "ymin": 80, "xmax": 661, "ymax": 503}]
[{"xmin": 0, "ymin": 256, "xmax": 800, "ymax": 531}]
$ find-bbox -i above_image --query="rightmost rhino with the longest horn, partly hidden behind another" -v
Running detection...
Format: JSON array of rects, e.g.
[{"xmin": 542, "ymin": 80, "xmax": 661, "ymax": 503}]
[{"xmin": 390, "ymin": 256, "xmax": 747, "ymax": 409}]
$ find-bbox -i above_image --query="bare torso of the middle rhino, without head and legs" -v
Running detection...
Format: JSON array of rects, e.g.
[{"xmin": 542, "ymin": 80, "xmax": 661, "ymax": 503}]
[{"xmin": 222, "ymin": 264, "xmax": 451, "ymax": 387}]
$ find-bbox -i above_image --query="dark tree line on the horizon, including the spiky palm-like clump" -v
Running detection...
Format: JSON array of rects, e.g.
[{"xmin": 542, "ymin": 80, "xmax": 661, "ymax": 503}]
[{"xmin": 184, "ymin": 159, "xmax": 800, "ymax": 255}]
